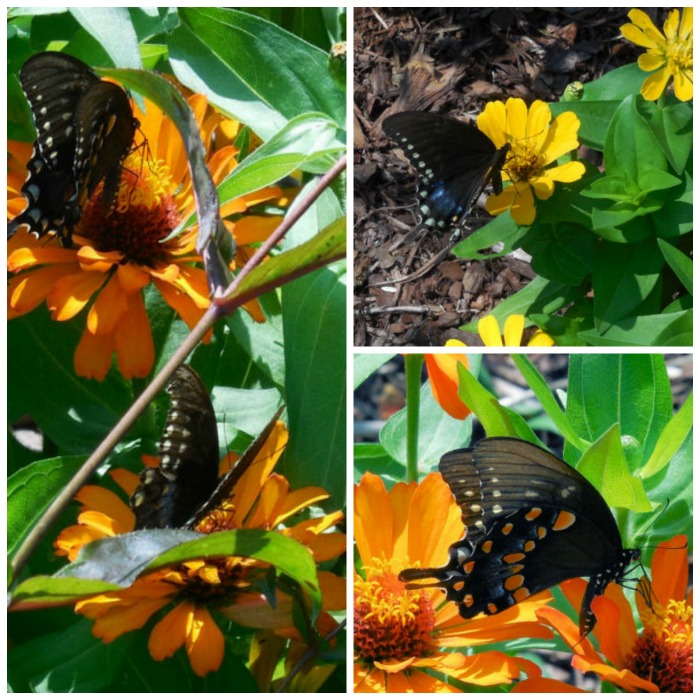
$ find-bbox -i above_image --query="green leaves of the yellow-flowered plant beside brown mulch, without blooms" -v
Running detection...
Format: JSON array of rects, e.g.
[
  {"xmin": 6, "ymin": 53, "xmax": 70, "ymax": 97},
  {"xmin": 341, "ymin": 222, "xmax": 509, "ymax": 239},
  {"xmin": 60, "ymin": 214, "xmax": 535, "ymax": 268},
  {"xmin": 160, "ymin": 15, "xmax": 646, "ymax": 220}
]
[{"xmin": 455, "ymin": 59, "xmax": 693, "ymax": 347}]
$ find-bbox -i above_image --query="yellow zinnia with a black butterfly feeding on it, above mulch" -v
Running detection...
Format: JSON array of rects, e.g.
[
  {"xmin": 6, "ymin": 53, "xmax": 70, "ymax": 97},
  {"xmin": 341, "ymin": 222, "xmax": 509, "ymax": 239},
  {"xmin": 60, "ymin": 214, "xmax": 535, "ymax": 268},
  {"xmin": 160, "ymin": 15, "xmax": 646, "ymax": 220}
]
[{"xmin": 476, "ymin": 97, "xmax": 585, "ymax": 225}]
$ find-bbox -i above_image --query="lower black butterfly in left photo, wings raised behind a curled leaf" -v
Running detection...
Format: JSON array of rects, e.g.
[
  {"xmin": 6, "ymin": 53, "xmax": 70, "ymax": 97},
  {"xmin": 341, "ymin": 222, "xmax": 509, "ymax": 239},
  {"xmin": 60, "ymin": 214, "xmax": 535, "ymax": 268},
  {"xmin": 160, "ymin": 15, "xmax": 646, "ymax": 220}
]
[{"xmin": 131, "ymin": 365, "xmax": 282, "ymax": 530}]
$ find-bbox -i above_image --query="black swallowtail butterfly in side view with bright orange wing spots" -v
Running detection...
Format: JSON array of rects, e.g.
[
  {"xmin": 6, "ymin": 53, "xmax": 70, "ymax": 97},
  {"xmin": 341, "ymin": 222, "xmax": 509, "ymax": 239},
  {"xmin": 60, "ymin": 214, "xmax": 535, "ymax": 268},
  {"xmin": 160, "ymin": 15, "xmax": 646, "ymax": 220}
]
[{"xmin": 399, "ymin": 438, "xmax": 640, "ymax": 637}]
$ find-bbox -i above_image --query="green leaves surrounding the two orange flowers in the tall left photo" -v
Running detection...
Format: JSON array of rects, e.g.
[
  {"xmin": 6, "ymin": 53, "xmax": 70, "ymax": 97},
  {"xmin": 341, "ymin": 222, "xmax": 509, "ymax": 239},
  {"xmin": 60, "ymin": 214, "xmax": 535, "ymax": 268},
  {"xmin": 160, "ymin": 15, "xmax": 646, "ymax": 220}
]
[{"xmin": 8, "ymin": 7, "xmax": 346, "ymax": 693}]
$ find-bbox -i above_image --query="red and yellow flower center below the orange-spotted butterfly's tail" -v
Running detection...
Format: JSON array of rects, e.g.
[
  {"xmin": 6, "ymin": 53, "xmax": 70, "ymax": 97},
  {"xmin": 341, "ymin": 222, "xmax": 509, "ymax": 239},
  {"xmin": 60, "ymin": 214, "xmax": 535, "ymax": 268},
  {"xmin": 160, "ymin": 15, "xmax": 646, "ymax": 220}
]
[{"xmin": 354, "ymin": 560, "xmax": 435, "ymax": 661}]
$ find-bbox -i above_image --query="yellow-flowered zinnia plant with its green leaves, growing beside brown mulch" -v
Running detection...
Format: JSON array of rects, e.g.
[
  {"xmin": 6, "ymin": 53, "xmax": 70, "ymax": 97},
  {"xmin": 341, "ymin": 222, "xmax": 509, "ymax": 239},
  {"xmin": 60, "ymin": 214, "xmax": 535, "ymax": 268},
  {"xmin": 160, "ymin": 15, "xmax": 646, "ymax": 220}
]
[{"xmin": 454, "ymin": 8, "xmax": 693, "ymax": 347}]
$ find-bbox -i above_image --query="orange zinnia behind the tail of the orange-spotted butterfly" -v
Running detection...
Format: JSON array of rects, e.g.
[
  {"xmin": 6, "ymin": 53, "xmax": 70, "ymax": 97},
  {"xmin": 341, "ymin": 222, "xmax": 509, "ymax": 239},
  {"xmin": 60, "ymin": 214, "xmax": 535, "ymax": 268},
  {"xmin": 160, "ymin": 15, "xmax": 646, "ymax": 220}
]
[{"xmin": 354, "ymin": 473, "xmax": 551, "ymax": 692}]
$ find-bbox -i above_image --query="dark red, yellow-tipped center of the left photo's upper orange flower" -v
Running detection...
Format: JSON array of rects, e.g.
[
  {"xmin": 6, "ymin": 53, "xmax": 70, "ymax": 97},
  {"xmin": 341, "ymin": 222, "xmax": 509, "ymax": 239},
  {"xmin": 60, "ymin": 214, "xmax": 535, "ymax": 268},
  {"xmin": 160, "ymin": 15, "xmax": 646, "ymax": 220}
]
[{"xmin": 76, "ymin": 152, "xmax": 180, "ymax": 266}]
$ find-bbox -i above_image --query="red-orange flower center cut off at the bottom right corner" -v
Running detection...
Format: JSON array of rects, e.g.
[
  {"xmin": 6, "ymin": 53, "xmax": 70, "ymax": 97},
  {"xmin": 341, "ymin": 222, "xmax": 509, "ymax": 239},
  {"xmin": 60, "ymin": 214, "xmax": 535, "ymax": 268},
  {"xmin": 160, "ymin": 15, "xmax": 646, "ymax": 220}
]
[{"xmin": 626, "ymin": 601, "xmax": 693, "ymax": 693}]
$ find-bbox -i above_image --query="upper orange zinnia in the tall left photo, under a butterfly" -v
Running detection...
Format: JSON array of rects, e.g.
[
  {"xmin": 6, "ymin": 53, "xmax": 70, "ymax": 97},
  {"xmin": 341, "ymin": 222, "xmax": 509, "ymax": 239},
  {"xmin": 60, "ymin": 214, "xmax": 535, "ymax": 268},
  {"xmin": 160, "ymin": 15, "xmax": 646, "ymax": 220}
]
[{"xmin": 8, "ymin": 95, "xmax": 281, "ymax": 380}]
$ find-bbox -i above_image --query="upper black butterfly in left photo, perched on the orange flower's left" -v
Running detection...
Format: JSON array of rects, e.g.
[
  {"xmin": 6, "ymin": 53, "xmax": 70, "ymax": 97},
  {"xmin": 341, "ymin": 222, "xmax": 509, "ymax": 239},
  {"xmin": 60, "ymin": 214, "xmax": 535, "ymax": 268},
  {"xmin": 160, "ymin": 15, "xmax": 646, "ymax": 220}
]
[{"xmin": 8, "ymin": 51, "xmax": 138, "ymax": 247}]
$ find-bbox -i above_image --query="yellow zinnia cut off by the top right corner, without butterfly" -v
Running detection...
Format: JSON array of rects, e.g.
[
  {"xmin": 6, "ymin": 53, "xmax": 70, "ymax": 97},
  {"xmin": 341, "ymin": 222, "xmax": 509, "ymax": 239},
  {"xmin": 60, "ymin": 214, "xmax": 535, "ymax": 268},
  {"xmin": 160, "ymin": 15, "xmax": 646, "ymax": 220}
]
[{"xmin": 620, "ymin": 7, "xmax": 693, "ymax": 102}]
